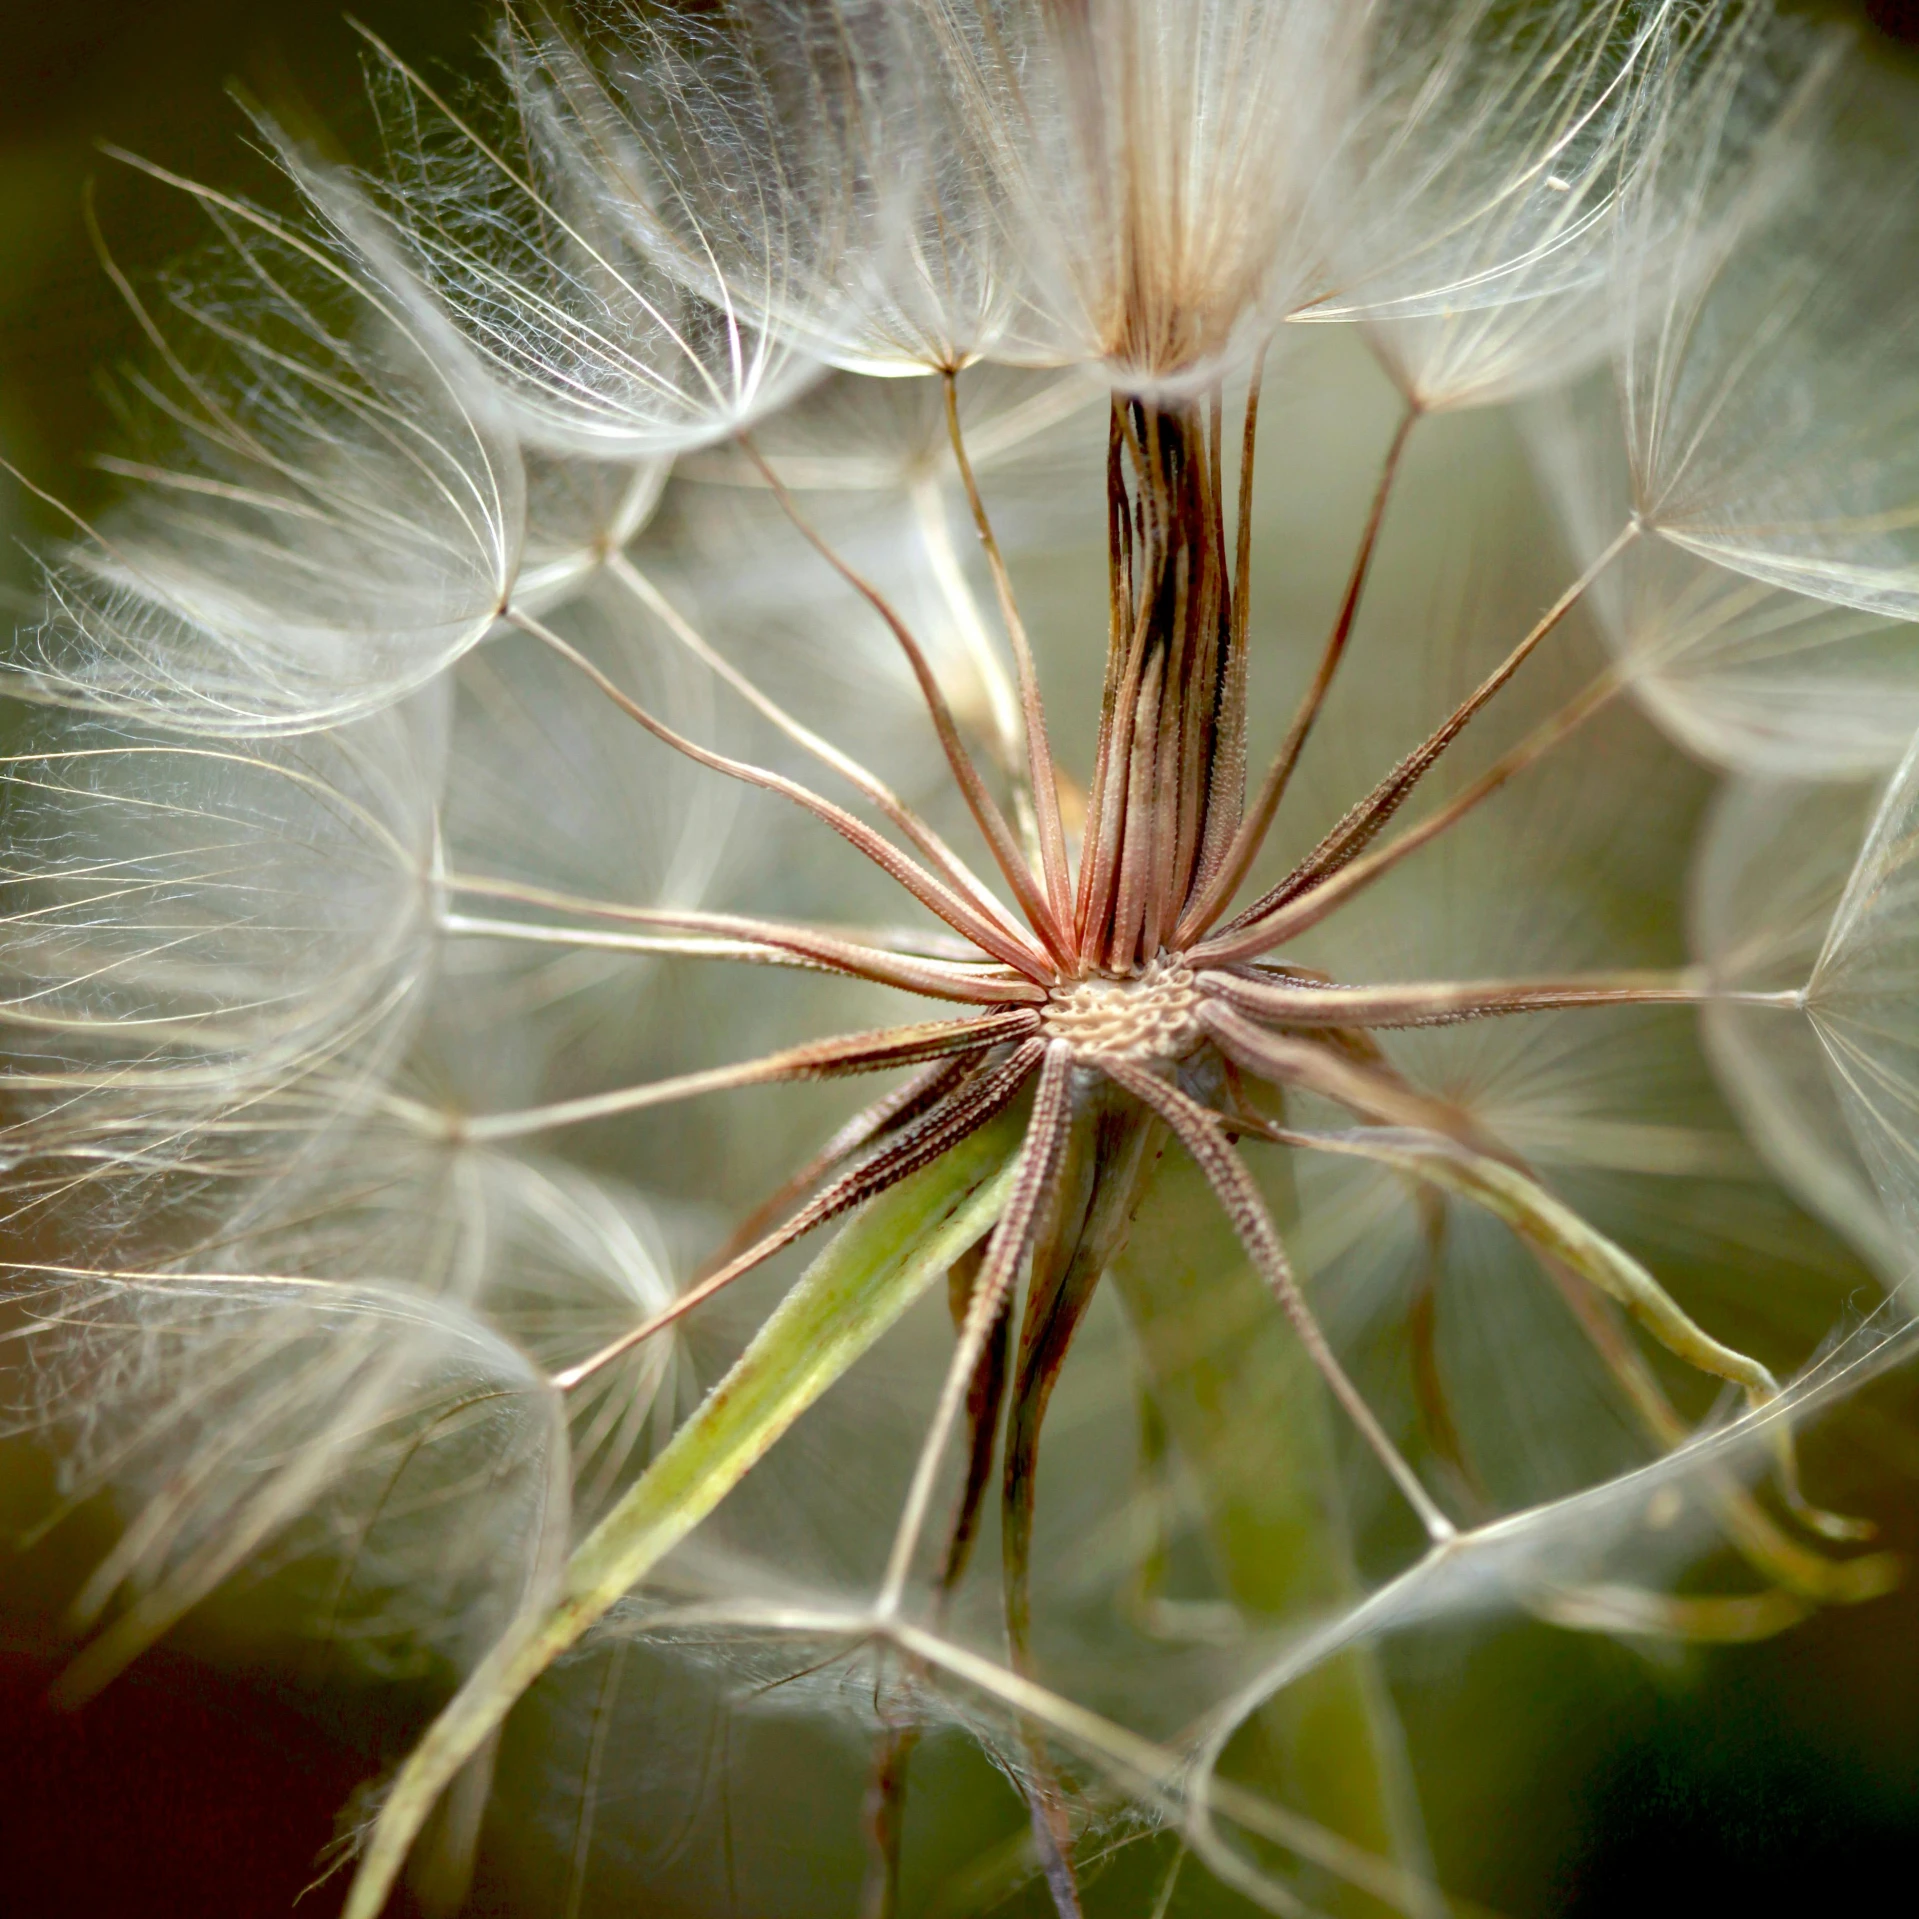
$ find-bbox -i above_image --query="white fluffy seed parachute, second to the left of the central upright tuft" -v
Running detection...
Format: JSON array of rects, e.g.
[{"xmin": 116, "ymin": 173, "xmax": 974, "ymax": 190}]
[{"xmin": 318, "ymin": 16, "xmax": 860, "ymax": 461}]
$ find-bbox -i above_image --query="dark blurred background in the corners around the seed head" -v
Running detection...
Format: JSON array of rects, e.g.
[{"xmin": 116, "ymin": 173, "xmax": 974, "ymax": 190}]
[{"xmin": 0, "ymin": 0, "xmax": 1919, "ymax": 1919}]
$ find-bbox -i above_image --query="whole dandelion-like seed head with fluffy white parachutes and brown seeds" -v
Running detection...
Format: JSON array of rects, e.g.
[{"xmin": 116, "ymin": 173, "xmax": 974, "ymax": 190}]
[{"xmin": 6, "ymin": 0, "xmax": 1919, "ymax": 1919}]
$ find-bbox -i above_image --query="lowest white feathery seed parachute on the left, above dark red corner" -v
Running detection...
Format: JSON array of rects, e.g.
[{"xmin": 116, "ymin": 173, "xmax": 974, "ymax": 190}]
[{"xmin": 16, "ymin": 1268, "xmax": 566, "ymax": 1696}]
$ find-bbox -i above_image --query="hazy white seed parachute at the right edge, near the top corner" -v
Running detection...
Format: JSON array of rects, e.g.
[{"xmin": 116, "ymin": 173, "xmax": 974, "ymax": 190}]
[{"xmin": 1622, "ymin": 37, "xmax": 1919, "ymax": 618}]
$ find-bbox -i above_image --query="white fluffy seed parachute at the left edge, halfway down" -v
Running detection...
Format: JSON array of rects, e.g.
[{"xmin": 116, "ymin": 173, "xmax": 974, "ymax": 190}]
[{"xmin": 0, "ymin": 693, "xmax": 445, "ymax": 1230}]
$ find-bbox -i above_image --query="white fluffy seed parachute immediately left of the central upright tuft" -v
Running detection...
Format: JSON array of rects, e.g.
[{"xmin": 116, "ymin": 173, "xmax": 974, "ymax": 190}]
[{"xmin": 547, "ymin": 0, "xmax": 1025, "ymax": 376}]
